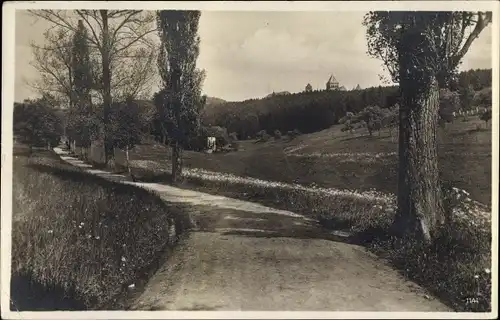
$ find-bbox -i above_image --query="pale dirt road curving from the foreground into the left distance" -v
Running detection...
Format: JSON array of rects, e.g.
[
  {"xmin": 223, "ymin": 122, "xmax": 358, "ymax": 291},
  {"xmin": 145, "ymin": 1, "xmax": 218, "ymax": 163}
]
[{"xmin": 52, "ymin": 149, "xmax": 452, "ymax": 311}]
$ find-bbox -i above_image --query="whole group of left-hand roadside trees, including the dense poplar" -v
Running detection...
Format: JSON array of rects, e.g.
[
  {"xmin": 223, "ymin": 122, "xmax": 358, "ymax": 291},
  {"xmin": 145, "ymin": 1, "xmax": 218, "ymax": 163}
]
[{"xmin": 30, "ymin": 10, "xmax": 205, "ymax": 181}]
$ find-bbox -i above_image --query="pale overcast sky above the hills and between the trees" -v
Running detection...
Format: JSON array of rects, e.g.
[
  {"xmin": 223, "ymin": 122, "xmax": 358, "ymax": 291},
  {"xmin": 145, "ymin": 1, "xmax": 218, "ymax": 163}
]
[{"xmin": 15, "ymin": 11, "xmax": 492, "ymax": 101}]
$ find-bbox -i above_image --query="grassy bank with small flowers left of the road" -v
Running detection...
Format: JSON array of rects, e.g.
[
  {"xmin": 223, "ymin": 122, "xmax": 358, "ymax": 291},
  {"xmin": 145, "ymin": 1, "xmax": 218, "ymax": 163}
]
[{"xmin": 11, "ymin": 147, "xmax": 189, "ymax": 310}]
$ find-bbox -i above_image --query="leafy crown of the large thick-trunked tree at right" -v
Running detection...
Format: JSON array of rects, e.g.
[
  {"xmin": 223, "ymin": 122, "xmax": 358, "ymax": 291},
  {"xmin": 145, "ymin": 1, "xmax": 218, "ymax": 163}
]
[{"xmin": 364, "ymin": 11, "xmax": 492, "ymax": 87}]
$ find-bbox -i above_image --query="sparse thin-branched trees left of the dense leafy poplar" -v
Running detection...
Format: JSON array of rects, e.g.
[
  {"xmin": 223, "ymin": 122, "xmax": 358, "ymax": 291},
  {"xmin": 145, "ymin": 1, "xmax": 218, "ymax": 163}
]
[{"xmin": 30, "ymin": 10, "xmax": 156, "ymax": 162}]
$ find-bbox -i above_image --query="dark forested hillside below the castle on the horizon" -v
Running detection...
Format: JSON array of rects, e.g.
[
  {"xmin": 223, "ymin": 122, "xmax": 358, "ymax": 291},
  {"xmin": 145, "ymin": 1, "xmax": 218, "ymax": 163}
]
[{"xmin": 203, "ymin": 69, "xmax": 491, "ymax": 139}]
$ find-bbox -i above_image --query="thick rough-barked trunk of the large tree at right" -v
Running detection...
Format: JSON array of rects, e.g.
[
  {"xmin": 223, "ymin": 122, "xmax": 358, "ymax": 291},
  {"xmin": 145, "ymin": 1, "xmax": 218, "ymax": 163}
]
[{"xmin": 395, "ymin": 77, "xmax": 444, "ymax": 243}]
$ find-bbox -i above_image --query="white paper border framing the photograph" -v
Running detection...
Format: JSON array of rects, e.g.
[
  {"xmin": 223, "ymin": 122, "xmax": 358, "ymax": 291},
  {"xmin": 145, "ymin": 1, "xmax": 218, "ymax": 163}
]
[{"xmin": 0, "ymin": 1, "xmax": 500, "ymax": 319}]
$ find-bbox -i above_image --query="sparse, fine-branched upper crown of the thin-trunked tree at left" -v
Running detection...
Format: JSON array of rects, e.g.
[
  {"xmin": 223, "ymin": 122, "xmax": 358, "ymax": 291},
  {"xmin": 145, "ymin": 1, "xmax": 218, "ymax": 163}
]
[{"xmin": 29, "ymin": 10, "xmax": 156, "ymax": 101}]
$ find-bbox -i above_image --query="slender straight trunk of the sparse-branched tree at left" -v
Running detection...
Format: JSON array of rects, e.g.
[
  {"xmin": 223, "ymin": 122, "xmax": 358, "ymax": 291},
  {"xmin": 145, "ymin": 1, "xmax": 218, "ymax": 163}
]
[{"xmin": 100, "ymin": 10, "xmax": 113, "ymax": 165}]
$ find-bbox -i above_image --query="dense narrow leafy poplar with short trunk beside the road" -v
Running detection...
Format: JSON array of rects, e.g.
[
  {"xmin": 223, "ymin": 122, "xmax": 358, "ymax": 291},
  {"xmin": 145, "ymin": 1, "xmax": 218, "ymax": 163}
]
[{"xmin": 155, "ymin": 10, "xmax": 206, "ymax": 181}]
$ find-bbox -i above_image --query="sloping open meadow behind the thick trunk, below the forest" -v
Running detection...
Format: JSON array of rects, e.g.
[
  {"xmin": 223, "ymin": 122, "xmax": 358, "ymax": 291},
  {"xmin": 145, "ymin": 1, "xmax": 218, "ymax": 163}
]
[{"xmin": 118, "ymin": 117, "xmax": 491, "ymax": 205}]
